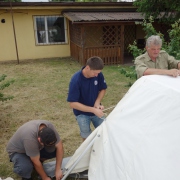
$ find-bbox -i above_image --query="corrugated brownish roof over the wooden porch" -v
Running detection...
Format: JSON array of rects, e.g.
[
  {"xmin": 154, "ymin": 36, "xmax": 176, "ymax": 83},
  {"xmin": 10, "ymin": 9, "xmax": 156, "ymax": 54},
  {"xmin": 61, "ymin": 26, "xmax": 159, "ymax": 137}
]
[{"xmin": 62, "ymin": 12, "xmax": 144, "ymax": 23}]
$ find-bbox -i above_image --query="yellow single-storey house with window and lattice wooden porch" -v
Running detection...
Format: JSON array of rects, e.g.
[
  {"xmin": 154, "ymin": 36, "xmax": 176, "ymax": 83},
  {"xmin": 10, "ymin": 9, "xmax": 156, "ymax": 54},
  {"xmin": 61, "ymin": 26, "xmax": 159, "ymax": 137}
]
[{"xmin": 0, "ymin": 2, "xmax": 169, "ymax": 65}]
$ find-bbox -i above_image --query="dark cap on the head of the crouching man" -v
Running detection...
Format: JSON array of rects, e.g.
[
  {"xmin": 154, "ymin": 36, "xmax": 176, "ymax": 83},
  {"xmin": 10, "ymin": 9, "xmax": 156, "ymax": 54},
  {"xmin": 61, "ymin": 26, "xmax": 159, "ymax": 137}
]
[{"xmin": 38, "ymin": 127, "xmax": 57, "ymax": 153}]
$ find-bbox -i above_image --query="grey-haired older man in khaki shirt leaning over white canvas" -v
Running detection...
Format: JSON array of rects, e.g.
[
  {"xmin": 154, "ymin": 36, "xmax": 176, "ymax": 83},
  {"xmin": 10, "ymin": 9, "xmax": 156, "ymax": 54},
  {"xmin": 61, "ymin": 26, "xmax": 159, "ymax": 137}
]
[{"xmin": 135, "ymin": 35, "xmax": 180, "ymax": 78}]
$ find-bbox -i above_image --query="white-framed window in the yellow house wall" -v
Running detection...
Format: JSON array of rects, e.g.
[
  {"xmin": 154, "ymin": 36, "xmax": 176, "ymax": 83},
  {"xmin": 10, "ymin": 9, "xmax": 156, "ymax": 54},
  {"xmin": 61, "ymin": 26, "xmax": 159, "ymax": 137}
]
[{"xmin": 34, "ymin": 16, "xmax": 67, "ymax": 45}]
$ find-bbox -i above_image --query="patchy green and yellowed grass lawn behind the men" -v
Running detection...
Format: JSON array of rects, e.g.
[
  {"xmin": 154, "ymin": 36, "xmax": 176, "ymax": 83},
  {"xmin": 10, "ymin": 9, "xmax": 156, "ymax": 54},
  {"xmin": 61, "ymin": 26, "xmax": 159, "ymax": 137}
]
[{"xmin": 0, "ymin": 58, "xmax": 135, "ymax": 180}]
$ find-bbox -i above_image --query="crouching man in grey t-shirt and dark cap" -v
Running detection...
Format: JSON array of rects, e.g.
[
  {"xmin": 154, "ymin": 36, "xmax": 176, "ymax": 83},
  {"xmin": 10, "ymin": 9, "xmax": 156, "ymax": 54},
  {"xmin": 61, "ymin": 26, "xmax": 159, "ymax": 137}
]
[{"xmin": 6, "ymin": 120, "xmax": 63, "ymax": 180}]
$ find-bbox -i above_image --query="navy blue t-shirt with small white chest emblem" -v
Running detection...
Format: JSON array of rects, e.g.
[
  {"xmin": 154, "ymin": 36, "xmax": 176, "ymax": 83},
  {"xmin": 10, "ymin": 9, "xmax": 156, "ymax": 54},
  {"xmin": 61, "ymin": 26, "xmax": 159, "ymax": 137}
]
[{"xmin": 67, "ymin": 67, "xmax": 107, "ymax": 116}]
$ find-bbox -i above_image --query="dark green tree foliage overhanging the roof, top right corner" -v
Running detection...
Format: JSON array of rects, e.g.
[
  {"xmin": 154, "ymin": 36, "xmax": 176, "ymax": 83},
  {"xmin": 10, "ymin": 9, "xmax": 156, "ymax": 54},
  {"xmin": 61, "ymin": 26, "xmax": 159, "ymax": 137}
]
[{"xmin": 133, "ymin": 0, "xmax": 180, "ymax": 23}]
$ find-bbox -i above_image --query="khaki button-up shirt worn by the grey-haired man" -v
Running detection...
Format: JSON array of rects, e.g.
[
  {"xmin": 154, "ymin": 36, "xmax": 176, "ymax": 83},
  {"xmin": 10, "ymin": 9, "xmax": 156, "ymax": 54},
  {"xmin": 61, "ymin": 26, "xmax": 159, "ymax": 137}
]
[{"xmin": 134, "ymin": 50, "xmax": 180, "ymax": 78}]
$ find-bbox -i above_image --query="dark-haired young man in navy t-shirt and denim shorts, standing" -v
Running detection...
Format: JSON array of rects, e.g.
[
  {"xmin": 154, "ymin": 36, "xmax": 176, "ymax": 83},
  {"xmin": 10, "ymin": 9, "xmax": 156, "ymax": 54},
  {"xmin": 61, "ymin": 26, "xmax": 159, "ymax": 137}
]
[{"xmin": 67, "ymin": 56, "xmax": 107, "ymax": 140}]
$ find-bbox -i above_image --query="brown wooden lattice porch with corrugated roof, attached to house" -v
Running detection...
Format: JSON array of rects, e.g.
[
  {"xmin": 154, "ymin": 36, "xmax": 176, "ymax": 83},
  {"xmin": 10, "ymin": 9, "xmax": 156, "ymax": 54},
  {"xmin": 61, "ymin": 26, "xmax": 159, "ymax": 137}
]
[{"xmin": 63, "ymin": 11, "xmax": 143, "ymax": 65}]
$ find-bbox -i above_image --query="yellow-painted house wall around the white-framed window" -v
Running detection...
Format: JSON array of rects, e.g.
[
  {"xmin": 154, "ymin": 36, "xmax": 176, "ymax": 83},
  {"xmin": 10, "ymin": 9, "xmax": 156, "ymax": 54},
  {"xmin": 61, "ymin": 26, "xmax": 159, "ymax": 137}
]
[{"xmin": 0, "ymin": 9, "xmax": 70, "ymax": 61}]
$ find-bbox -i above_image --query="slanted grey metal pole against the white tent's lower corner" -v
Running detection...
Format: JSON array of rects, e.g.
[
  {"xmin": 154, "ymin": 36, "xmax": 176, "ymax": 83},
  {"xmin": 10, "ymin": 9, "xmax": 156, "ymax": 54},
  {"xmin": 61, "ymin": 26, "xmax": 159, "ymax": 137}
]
[{"xmin": 61, "ymin": 135, "xmax": 97, "ymax": 180}]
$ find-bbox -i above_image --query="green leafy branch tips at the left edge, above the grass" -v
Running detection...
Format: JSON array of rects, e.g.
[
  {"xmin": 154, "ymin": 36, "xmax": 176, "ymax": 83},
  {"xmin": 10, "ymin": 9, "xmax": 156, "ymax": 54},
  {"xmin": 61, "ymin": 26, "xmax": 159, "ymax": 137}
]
[{"xmin": 0, "ymin": 74, "xmax": 14, "ymax": 102}]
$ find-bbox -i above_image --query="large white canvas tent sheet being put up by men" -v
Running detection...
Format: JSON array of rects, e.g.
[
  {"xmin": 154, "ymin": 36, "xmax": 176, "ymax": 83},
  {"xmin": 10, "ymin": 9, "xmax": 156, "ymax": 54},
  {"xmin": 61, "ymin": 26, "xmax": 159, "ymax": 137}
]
[{"xmin": 66, "ymin": 75, "xmax": 180, "ymax": 180}]
